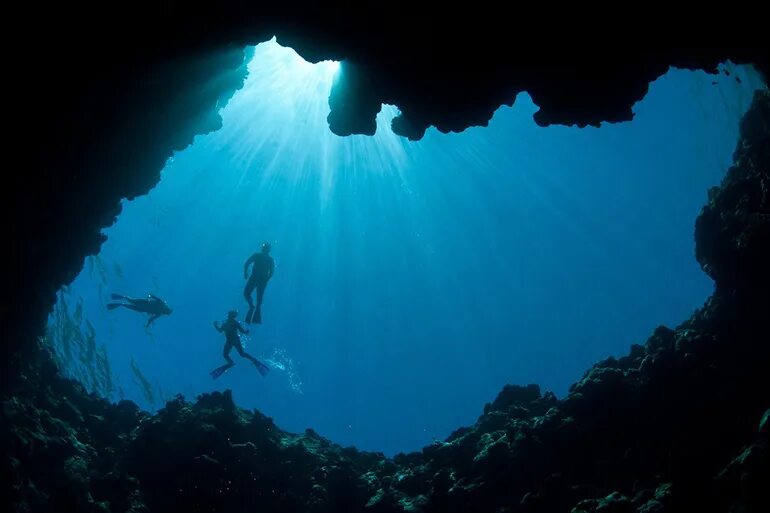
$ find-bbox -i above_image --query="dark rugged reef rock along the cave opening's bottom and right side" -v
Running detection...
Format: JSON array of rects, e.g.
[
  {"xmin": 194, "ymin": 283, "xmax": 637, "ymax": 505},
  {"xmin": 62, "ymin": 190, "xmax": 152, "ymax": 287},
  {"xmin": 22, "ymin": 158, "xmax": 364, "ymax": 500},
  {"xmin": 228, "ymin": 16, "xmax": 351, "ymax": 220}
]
[{"xmin": 0, "ymin": 91, "xmax": 770, "ymax": 513}]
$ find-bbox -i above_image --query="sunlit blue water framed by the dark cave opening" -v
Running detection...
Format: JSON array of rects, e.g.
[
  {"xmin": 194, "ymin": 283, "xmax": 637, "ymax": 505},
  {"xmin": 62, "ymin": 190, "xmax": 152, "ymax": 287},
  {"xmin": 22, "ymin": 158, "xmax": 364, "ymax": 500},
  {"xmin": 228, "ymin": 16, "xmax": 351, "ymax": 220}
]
[{"xmin": 55, "ymin": 42, "xmax": 758, "ymax": 454}]
